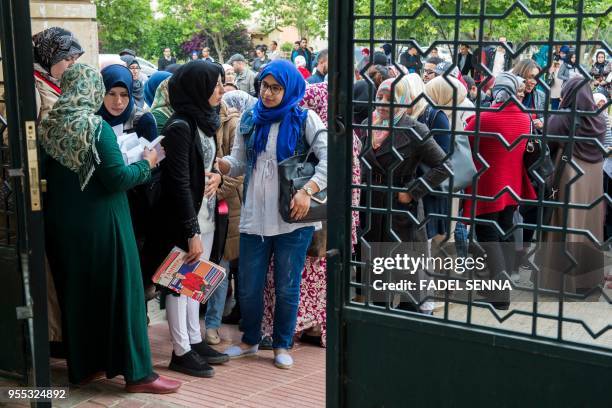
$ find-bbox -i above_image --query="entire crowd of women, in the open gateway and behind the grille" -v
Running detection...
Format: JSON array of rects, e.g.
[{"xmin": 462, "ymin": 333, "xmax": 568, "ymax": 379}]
[{"xmin": 28, "ymin": 23, "xmax": 611, "ymax": 393}]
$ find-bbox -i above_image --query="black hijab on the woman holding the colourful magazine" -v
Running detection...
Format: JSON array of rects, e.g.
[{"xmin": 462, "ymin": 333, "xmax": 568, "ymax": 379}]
[{"xmin": 168, "ymin": 60, "xmax": 225, "ymax": 137}]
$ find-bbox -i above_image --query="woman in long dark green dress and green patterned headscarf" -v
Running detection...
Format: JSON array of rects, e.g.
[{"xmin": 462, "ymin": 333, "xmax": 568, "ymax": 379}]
[{"xmin": 41, "ymin": 64, "xmax": 180, "ymax": 393}]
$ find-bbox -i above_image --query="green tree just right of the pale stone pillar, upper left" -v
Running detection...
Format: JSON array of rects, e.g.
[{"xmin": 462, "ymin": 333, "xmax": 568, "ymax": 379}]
[{"xmin": 94, "ymin": 0, "xmax": 154, "ymax": 54}]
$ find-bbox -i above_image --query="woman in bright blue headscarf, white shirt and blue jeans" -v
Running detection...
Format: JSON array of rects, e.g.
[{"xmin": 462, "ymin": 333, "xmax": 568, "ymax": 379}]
[{"xmin": 217, "ymin": 60, "xmax": 327, "ymax": 368}]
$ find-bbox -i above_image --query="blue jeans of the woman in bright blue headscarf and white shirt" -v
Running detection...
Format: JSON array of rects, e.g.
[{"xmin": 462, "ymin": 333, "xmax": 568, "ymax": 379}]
[{"xmin": 238, "ymin": 227, "xmax": 314, "ymax": 349}]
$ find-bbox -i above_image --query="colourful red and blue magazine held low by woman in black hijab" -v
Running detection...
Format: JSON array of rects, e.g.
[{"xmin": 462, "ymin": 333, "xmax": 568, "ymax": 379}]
[{"xmin": 153, "ymin": 247, "xmax": 226, "ymax": 303}]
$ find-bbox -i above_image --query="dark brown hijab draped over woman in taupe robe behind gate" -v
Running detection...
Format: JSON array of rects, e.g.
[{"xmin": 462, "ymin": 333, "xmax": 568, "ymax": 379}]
[{"xmin": 548, "ymin": 76, "xmax": 607, "ymax": 163}]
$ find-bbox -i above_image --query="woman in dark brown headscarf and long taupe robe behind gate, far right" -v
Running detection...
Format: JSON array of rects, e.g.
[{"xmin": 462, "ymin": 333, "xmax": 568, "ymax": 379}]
[{"xmin": 539, "ymin": 77, "xmax": 607, "ymax": 293}]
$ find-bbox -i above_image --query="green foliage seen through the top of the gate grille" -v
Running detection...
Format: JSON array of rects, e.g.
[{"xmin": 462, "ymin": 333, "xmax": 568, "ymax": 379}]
[{"xmin": 355, "ymin": 0, "xmax": 611, "ymax": 54}]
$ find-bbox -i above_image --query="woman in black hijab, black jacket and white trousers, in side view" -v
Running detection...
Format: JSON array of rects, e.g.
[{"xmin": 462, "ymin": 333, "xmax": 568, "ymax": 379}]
[{"xmin": 145, "ymin": 61, "xmax": 229, "ymax": 377}]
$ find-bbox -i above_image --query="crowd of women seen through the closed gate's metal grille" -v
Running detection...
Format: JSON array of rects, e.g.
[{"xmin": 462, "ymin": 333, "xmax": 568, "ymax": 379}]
[{"xmin": 353, "ymin": 44, "xmax": 612, "ymax": 314}]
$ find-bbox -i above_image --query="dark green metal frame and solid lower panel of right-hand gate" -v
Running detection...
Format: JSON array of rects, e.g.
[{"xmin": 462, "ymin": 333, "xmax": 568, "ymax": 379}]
[{"xmin": 327, "ymin": 0, "xmax": 612, "ymax": 408}]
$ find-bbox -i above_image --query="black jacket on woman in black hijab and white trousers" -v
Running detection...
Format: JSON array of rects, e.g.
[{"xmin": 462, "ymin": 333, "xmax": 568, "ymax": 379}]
[{"xmin": 144, "ymin": 113, "xmax": 214, "ymax": 271}]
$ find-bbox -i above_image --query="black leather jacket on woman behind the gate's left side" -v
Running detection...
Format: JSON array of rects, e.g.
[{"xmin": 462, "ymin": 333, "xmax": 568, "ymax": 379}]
[{"xmin": 361, "ymin": 115, "xmax": 450, "ymax": 242}]
